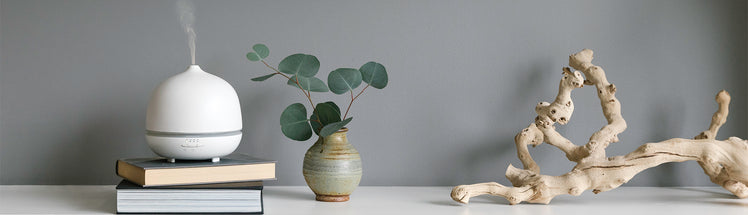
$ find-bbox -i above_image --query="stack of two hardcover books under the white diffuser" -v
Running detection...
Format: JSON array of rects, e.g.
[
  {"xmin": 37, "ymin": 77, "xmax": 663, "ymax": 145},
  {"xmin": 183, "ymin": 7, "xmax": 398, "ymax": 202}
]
[{"xmin": 116, "ymin": 154, "xmax": 275, "ymax": 214}]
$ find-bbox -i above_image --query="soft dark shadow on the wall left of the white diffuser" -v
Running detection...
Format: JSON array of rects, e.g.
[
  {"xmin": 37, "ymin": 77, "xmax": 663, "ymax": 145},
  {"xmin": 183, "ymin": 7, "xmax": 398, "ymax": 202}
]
[{"xmin": 52, "ymin": 106, "xmax": 150, "ymax": 184}]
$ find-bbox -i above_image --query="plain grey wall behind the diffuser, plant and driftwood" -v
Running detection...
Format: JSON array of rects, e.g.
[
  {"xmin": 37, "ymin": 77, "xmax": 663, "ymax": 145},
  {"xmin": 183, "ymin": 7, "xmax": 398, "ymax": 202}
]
[{"xmin": 0, "ymin": 0, "xmax": 748, "ymax": 186}]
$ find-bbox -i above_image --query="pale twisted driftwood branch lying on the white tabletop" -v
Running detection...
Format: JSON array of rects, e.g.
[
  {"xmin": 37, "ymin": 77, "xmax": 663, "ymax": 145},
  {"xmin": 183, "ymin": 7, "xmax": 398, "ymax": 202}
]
[{"xmin": 451, "ymin": 49, "xmax": 748, "ymax": 204}]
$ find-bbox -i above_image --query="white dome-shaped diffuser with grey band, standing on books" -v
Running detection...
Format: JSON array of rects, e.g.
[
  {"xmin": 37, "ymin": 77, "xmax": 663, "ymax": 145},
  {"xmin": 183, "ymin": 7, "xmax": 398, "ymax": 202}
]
[{"xmin": 145, "ymin": 65, "xmax": 242, "ymax": 162}]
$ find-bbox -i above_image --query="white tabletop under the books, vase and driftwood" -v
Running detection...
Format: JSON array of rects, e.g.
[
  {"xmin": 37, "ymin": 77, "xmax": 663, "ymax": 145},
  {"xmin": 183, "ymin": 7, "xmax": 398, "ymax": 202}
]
[{"xmin": 0, "ymin": 185, "xmax": 748, "ymax": 215}]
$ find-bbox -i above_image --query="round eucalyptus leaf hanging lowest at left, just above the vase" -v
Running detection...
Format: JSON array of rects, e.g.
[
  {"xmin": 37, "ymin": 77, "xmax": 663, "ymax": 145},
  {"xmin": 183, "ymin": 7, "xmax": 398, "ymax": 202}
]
[{"xmin": 280, "ymin": 103, "xmax": 312, "ymax": 141}]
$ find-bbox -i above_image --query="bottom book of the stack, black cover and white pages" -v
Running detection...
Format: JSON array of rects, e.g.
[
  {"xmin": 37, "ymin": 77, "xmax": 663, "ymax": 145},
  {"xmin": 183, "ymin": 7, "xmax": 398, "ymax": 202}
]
[{"xmin": 117, "ymin": 180, "xmax": 264, "ymax": 214}]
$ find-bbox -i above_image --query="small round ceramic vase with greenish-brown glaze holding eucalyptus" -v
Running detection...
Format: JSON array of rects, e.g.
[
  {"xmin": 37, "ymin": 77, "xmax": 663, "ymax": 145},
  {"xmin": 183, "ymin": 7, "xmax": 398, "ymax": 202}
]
[{"xmin": 303, "ymin": 128, "xmax": 362, "ymax": 202}]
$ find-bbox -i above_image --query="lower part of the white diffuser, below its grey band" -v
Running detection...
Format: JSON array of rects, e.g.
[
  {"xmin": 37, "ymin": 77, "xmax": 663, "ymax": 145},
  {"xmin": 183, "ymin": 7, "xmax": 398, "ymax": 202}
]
[{"xmin": 145, "ymin": 131, "xmax": 242, "ymax": 162}]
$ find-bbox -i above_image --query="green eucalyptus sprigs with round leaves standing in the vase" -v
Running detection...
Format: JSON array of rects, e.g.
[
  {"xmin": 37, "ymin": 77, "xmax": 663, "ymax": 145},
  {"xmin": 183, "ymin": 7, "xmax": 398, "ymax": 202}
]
[{"xmin": 247, "ymin": 44, "xmax": 387, "ymax": 141}]
